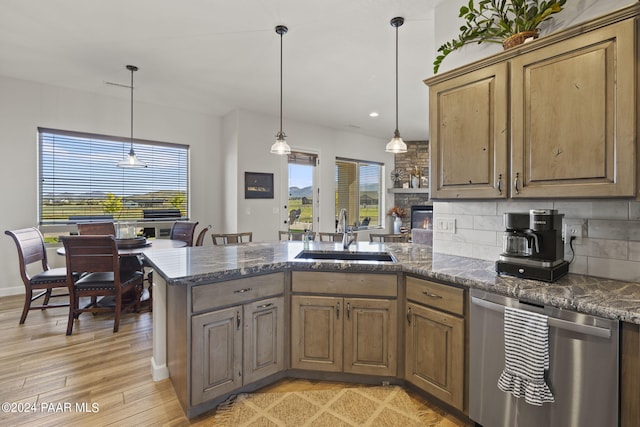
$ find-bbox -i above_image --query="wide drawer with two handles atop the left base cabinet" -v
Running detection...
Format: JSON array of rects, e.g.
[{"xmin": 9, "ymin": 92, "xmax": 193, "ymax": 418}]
[{"xmin": 191, "ymin": 273, "xmax": 284, "ymax": 312}]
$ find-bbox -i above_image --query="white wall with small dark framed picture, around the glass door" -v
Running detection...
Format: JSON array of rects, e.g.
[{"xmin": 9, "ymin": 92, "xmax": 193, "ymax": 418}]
[{"xmin": 228, "ymin": 110, "xmax": 393, "ymax": 241}]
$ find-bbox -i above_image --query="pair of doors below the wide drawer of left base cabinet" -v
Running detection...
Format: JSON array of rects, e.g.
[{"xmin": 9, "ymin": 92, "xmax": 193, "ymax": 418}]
[{"xmin": 191, "ymin": 297, "xmax": 285, "ymax": 405}]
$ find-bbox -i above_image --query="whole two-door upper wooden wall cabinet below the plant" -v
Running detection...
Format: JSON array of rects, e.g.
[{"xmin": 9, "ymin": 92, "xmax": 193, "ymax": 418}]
[{"xmin": 426, "ymin": 5, "xmax": 639, "ymax": 199}]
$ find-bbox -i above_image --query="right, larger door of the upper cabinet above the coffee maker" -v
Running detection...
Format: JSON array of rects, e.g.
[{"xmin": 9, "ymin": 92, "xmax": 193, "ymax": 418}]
[{"xmin": 510, "ymin": 19, "xmax": 637, "ymax": 198}]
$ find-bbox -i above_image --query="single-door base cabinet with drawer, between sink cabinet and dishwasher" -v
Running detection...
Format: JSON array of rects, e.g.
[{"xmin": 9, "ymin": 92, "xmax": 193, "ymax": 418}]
[{"xmin": 405, "ymin": 276, "xmax": 465, "ymax": 411}]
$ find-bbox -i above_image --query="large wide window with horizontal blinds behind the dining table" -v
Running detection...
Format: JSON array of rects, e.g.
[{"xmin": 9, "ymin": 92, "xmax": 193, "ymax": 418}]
[{"xmin": 38, "ymin": 128, "xmax": 189, "ymax": 225}]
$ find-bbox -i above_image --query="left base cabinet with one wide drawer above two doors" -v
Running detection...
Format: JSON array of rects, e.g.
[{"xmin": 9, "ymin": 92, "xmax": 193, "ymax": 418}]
[{"xmin": 167, "ymin": 272, "xmax": 287, "ymax": 416}]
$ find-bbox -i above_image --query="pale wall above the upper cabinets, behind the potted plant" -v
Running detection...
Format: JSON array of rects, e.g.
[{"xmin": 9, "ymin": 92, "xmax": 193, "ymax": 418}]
[{"xmin": 433, "ymin": 0, "xmax": 636, "ymax": 73}]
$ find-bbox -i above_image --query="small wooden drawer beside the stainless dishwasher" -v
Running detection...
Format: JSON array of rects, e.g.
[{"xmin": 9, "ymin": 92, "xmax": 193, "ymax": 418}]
[{"xmin": 407, "ymin": 277, "xmax": 464, "ymax": 316}]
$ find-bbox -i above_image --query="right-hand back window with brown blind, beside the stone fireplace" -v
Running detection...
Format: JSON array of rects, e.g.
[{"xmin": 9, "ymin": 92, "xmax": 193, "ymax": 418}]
[{"xmin": 336, "ymin": 159, "xmax": 382, "ymax": 228}]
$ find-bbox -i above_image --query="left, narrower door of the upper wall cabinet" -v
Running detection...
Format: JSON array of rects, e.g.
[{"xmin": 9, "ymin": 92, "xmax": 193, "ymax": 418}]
[{"xmin": 429, "ymin": 63, "xmax": 508, "ymax": 199}]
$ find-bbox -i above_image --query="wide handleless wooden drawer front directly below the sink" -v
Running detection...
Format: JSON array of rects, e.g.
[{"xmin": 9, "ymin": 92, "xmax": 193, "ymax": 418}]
[{"xmin": 291, "ymin": 271, "xmax": 398, "ymax": 298}]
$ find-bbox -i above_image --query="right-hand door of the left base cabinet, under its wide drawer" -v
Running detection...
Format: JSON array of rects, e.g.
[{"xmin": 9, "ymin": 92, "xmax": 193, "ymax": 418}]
[{"xmin": 243, "ymin": 297, "xmax": 285, "ymax": 384}]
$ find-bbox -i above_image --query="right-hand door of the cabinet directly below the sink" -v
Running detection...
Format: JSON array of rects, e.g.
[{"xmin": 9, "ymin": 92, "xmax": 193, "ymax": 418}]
[{"xmin": 343, "ymin": 298, "xmax": 398, "ymax": 376}]
